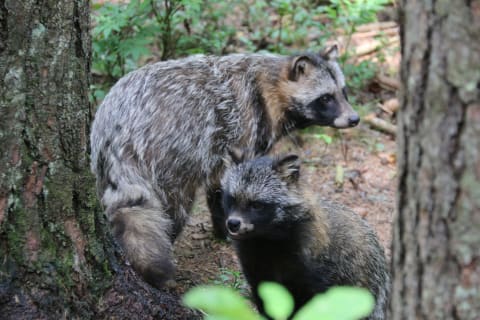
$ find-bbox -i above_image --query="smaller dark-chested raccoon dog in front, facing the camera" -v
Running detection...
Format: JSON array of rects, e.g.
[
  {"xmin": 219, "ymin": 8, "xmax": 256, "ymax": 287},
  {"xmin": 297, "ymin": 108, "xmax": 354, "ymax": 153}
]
[{"xmin": 222, "ymin": 155, "xmax": 390, "ymax": 319}]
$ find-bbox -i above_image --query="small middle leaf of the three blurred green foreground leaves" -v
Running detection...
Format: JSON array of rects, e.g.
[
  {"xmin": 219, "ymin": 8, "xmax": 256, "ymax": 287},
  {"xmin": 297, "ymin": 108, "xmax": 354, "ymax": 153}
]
[{"xmin": 258, "ymin": 282, "xmax": 295, "ymax": 320}]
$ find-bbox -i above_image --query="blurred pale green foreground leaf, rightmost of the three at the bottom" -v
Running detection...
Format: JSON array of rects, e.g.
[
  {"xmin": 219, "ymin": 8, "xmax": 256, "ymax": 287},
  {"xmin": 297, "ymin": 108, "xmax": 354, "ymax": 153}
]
[{"xmin": 293, "ymin": 287, "xmax": 375, "ymax": 320}]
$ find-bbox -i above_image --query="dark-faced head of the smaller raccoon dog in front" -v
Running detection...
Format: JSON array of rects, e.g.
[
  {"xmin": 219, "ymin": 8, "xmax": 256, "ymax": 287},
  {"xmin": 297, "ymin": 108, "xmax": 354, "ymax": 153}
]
[{"xmin": 222, "ymin": 151, "xmax": 301, "ymax": 239}]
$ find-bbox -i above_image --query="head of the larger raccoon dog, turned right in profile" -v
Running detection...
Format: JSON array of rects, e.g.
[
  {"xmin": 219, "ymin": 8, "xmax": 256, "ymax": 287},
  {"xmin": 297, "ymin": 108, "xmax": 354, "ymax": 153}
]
[{"xmin": 287, "ymin": 46, "xmax": 360, "ymax": 128}]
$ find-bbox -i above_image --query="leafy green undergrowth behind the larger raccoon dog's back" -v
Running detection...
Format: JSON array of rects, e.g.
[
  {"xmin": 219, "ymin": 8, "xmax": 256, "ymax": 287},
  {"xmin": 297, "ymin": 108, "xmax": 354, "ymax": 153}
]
[{"xmin": 92, "ymin": 0, "xmax": 389, "ymax": 102}]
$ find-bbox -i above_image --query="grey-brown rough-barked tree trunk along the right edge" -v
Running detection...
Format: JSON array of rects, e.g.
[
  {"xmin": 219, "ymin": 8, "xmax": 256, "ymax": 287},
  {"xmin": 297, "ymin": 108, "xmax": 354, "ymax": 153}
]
[{"xmin": 391, "ymin": 0, "xmax": 480, "ymax": 320}]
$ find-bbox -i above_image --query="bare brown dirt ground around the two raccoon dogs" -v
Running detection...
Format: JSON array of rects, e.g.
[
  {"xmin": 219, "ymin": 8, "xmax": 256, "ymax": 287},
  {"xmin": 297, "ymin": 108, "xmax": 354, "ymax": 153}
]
[{"xmin": 171, "ymin": 124, "xmax": 396, "ymax": 300}]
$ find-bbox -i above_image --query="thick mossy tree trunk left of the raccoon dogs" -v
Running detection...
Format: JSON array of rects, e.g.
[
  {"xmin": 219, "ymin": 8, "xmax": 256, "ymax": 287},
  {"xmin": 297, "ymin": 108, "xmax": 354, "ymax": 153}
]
[{"xmin": 0, "ymin": 0, "xmax": 197, "ymax": 319}]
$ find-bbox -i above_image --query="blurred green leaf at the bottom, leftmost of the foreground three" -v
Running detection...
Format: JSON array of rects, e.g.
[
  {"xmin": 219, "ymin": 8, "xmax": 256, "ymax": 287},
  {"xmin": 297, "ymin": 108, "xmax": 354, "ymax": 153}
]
[{"xmin": 183, "ymin": 286, "xmax": 259, "ymax": 320}]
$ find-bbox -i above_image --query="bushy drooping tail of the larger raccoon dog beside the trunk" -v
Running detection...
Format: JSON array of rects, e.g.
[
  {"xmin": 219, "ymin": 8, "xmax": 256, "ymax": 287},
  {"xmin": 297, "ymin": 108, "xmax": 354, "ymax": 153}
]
[{"xmin": 96, "ymin": 145, "xmax": 179, "ymax": 287}]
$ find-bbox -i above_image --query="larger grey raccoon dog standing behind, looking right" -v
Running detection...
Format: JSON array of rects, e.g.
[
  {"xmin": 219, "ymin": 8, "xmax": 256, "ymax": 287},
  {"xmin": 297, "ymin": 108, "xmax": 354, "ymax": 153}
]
[{"xmin": 91, "ymin": 47, "xmax": 359, "ymax": 287}]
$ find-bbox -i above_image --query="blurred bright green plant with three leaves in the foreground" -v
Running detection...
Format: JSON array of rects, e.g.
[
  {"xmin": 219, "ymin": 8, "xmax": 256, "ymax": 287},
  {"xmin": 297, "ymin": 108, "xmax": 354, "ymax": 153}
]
[{"xmin": 183, "ymin": 282, "xmax": 375, "ymax": 320}]
